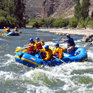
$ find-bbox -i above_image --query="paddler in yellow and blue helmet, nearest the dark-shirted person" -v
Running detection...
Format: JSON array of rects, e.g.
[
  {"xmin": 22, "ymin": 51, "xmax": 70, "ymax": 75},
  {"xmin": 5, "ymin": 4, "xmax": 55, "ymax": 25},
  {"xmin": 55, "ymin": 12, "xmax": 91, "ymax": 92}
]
[{"xmin": 53, "ymin": 43, "xmax": 64, "ymax": 59}]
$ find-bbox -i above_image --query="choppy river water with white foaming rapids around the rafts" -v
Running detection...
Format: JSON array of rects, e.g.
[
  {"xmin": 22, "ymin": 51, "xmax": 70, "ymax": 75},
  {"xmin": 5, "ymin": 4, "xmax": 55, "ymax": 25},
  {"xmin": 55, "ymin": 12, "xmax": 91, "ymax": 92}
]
[{"xmin": 0, "ymin": 29, "xmax": 93, "ymax": 93}]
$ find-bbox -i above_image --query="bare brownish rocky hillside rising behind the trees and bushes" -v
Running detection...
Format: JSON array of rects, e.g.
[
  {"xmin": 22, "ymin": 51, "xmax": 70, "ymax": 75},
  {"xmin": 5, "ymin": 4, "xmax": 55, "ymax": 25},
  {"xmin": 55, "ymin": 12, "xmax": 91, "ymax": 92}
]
[{"xmin": 26, "ymin": 0, "xmax": 93, "ymax": 18}]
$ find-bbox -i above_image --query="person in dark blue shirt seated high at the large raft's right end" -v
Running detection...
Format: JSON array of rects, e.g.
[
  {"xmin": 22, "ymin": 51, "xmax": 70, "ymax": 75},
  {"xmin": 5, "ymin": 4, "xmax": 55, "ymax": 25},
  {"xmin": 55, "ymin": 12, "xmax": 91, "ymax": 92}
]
[{"xmin": 60, "ymin": 34, "xmax": 75, "ymax": 53}]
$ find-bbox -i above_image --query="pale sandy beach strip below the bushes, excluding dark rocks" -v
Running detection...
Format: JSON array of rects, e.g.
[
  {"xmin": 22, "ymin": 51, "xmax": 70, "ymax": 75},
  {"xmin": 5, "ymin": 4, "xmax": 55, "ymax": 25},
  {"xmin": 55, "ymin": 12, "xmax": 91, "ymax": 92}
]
[{"xmin": 38, "ymin": 28, "xmax": 93, "ymax": 36}]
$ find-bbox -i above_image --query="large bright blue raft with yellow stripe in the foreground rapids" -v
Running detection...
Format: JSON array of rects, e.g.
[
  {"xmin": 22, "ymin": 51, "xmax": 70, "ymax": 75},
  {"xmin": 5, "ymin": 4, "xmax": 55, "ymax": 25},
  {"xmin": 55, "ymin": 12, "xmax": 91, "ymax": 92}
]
[{"xmin": 15, "ymin": 47, "xmax": 87, "ymax": 67}]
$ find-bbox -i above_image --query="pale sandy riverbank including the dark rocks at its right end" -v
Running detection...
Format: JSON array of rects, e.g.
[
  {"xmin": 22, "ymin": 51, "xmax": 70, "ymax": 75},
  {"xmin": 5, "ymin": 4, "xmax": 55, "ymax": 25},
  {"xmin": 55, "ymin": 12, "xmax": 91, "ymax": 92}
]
[{"xmin": 38, "ymin": 28, "xmax": 93, "ymax": 42}]
